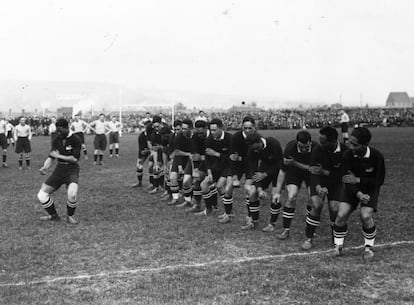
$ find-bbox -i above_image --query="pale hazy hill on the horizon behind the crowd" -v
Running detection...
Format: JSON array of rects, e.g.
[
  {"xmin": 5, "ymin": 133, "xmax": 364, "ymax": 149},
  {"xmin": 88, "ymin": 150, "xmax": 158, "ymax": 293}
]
[{"xmin": 0, "ymin": 80, "xmax": 316, "ymax": 112}]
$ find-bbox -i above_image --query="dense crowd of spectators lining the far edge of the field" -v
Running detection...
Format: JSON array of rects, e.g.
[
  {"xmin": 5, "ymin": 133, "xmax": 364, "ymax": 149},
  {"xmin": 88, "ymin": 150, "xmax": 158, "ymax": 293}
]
[{"xmin": 3, "ymin": 107, "xmax": 414, "ymax": 135}]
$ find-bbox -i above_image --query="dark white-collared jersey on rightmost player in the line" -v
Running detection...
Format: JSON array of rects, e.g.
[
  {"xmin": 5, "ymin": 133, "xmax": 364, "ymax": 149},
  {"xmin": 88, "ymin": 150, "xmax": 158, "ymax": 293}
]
[{"xmin": 343, "ymin": 147, "xmax": 385, "ymax": 194}]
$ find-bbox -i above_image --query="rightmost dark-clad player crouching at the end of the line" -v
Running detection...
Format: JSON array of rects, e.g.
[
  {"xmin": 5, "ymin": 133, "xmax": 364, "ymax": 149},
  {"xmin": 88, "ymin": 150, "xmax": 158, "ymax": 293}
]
[{"xmin": 334, "ymin": 127, "xmax": 385, "ymax": 261}]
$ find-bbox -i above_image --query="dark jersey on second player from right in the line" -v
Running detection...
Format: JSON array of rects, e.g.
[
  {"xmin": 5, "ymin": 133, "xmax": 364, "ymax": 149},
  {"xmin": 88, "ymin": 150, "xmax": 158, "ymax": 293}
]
[{"xmin": 310, "ymin": 142, "xmax": 348, "ymax": 185}]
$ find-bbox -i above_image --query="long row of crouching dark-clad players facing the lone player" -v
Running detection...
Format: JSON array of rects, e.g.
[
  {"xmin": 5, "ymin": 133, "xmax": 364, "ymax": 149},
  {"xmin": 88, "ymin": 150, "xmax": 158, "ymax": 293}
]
[{"xmin": 134, "ymin": 116, "xmax": 385, "ymax": 257}]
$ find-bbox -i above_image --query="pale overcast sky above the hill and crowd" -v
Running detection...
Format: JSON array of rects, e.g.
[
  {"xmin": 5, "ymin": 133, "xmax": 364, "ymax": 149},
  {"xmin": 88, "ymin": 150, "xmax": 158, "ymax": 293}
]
[{"xmin": 0, "ymin": 0, "xmax": 414, "ymax": 105}]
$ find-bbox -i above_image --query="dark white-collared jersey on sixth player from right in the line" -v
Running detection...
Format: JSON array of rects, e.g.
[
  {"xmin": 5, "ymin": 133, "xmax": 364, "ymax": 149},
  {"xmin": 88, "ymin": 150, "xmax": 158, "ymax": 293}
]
[{"xmin": 206, "ymin": 131, "xmax": 231, "ymax": 171}]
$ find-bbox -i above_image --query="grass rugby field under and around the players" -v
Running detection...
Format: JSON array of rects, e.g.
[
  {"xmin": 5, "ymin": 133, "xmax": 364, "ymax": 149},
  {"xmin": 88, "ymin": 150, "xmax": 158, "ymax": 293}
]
[{"xmin": 0, "ymin": 128, "xmax": 414, "ymax": 305}]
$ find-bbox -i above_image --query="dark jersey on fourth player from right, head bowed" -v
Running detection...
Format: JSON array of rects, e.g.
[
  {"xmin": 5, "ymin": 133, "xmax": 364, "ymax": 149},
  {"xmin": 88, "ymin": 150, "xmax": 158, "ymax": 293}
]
[{"xmin": 247, "ymin": 137, "xmax": 283, "ymax": 177}]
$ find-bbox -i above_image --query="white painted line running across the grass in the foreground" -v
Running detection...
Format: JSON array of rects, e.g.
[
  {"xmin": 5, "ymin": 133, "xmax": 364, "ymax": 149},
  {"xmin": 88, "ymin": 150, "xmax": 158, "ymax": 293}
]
[{"xmin": 0, "ymin": 240, "xmax": 414, "ymax": 287}]
